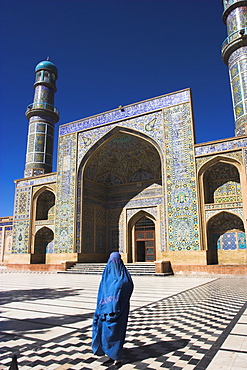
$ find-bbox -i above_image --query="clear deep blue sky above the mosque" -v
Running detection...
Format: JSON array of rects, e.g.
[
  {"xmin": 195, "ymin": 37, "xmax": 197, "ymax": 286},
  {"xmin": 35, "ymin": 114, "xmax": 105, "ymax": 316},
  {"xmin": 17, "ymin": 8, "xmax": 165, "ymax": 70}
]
[{"xmin": 0, "ymin": 0, "xmax": 234, "ymax": 216}]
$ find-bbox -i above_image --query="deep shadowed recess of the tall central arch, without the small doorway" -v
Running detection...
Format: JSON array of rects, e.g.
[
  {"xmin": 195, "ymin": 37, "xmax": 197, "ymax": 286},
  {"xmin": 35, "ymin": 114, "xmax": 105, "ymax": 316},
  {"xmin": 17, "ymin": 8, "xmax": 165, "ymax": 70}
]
[{"xmin": 77, "ymin": 130, "xmax": 162, "ymax": 261}]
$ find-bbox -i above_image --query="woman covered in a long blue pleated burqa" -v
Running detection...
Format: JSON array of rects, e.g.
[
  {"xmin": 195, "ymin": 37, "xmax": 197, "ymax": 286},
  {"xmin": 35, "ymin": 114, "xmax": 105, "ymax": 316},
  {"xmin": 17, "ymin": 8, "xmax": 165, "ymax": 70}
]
[{"xmin": 92, "ymin": 252, "xmax": 133, "ymax": 361}]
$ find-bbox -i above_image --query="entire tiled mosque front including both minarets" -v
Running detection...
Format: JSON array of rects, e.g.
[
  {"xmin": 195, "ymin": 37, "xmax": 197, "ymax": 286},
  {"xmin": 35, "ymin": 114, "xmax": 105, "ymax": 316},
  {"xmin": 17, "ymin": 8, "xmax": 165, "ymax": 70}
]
[{"xmin": 0, "ymin": 0, "xmax": 247, "ymax": 265}]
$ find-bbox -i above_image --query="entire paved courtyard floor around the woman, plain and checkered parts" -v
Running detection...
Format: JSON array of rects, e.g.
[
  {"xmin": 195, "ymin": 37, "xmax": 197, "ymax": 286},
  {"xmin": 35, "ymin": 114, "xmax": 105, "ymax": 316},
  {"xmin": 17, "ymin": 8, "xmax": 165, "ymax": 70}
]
[{"xmin": 0, "ymin": 270, "xmax": 247, "ymax": 370}]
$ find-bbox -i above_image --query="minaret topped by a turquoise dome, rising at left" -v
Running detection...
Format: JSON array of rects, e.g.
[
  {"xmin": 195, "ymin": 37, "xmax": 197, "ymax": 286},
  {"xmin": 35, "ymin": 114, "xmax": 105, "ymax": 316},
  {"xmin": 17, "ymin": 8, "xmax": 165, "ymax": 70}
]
[{"xmin": 24, "ymin": 58, "xmax": 59, "ymax": 177}]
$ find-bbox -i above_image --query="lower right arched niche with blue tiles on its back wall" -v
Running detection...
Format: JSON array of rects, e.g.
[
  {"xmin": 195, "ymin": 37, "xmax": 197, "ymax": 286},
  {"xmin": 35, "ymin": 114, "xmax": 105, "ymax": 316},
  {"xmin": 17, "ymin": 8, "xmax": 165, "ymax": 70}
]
[{"xmin": 207, "ymin": 212, "xmax": 246, "ymax": 265}]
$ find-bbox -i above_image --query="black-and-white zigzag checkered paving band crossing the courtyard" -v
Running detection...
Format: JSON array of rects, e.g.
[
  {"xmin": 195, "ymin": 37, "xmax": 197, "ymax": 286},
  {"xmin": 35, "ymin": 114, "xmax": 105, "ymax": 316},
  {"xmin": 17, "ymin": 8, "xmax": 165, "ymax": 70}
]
[{"xmin": 0, "ymin": 277, "xmax": 247, "ymax": 370}]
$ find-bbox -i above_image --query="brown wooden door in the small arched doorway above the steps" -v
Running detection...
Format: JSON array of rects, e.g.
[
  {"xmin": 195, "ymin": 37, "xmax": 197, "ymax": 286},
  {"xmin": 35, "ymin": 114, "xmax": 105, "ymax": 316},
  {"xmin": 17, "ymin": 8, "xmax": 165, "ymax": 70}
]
[{"xmin": 135, "ymin": 217, "xmax": 155, "ymax": 262}]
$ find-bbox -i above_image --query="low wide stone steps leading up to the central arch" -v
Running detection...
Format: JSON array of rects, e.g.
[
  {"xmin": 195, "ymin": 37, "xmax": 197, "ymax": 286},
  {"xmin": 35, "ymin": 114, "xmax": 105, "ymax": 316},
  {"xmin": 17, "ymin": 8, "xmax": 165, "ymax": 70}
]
[{"xmin": 59, "ymin": 262, "xmax": 171, "ymax": 276}]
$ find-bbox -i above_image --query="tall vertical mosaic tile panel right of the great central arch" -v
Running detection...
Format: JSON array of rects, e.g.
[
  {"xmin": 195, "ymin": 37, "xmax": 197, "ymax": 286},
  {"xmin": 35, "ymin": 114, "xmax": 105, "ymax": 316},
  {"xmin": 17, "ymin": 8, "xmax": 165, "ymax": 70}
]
[{"xmin": 164, "ymin": 103, "xmax": 199, "ymax": 251}]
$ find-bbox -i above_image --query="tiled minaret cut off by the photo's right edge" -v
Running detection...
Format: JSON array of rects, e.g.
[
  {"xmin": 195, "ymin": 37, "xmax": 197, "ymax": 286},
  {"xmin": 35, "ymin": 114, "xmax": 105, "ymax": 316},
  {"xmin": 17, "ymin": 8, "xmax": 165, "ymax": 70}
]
[{"xmin": 222, "ymin": 0, "xmax": 247, "ymax": 136}]
